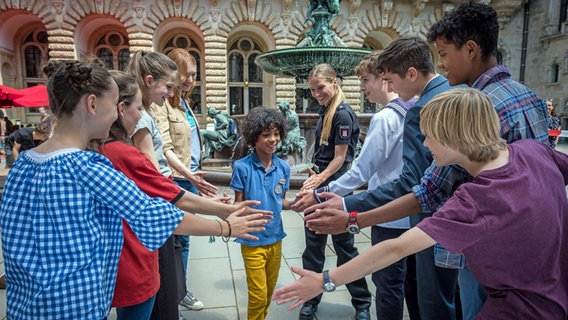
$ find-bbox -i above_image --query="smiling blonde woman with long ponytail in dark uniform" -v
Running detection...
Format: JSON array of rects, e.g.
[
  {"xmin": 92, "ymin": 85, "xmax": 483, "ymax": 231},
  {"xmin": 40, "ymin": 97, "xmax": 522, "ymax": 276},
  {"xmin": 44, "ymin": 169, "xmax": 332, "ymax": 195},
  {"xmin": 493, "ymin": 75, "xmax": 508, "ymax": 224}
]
[{"xmin": 300, "ymin": 64, "xmax": 371, "ymax": 319}]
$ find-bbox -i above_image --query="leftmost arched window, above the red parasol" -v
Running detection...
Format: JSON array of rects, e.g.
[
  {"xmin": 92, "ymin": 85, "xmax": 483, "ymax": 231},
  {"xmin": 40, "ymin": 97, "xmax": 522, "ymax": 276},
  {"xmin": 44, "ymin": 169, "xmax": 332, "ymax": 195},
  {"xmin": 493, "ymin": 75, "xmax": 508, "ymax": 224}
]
[{"xmin": 22, "ymin": 30, "xmax": 48, "ymax": 87}]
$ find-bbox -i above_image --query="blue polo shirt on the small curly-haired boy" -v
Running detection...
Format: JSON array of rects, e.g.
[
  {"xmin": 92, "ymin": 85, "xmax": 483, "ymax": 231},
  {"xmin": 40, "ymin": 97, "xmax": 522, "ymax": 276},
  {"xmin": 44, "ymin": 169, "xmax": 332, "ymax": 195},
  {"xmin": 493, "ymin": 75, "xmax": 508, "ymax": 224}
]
[{"xmin": 230, "ymin": 151, "xmax": 290, "ymax": 246}]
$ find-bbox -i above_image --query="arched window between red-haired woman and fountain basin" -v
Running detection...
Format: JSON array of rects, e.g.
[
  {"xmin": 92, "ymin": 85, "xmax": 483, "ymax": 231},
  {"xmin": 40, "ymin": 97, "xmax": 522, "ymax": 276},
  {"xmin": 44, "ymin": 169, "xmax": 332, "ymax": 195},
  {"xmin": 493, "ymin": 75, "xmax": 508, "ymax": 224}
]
[{"xmin": 227, "ymin": 37, "xmax": 264, "ymax": 114}]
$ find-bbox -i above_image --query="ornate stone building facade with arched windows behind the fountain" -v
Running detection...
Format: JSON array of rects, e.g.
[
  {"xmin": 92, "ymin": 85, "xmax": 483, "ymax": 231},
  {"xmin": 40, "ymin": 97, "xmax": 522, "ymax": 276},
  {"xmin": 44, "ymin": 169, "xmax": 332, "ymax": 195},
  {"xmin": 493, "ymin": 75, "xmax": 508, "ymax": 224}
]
[{"xmin": 0, "ymin": 0, "xmax": 568, "ymax": 127}]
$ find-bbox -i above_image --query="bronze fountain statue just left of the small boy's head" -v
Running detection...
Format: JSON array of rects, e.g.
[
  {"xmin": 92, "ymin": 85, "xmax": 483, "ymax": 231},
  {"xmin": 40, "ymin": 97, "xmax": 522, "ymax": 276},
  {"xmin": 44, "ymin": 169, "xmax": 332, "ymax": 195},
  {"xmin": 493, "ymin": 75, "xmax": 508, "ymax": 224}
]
[{"xmin": 201, "ymin": 107, "xmax": 239, "ymax": 159}]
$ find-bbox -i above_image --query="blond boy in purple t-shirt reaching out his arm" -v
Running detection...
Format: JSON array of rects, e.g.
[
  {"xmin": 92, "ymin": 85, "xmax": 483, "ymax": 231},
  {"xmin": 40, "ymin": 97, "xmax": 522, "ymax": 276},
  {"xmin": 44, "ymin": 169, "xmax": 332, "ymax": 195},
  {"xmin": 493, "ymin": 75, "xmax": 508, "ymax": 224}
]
[{"xmin": 273, "ymin": 88, "xmax": 568, "ymax": 319}]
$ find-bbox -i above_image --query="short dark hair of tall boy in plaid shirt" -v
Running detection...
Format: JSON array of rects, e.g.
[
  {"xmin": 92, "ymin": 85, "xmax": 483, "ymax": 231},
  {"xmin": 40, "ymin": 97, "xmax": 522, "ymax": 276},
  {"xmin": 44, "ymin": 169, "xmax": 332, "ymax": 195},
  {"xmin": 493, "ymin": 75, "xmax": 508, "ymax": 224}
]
[{"xmin": 428, "ymin": 2, "xmax": 499, "ymax": 61}]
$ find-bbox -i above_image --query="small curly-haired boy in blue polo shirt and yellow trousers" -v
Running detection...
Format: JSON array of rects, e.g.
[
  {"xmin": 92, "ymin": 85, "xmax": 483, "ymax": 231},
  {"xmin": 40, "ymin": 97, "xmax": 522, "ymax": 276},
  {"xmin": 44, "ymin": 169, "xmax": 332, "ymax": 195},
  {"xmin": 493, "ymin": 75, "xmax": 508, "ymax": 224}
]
[{"xmin": 231, "ymin": 107, "xmax": 292, "ymax": 319}]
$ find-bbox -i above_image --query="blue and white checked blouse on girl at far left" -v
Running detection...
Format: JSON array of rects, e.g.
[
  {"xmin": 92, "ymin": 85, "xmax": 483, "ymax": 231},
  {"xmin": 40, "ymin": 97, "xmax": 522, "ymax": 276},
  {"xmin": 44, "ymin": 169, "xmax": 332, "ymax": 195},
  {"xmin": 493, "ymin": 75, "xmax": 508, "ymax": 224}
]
[{"xmin": 0, "ymin": 148, "xmax": 183, "ymax": 319}]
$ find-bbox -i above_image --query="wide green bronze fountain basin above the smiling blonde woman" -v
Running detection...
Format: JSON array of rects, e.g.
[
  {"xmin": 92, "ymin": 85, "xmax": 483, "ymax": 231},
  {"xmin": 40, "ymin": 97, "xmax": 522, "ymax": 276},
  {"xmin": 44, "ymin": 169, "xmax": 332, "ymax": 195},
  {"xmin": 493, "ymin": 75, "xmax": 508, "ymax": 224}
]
[{"xmin": 254, "ymin": 47, "xmax": 371, "ymax": 78}]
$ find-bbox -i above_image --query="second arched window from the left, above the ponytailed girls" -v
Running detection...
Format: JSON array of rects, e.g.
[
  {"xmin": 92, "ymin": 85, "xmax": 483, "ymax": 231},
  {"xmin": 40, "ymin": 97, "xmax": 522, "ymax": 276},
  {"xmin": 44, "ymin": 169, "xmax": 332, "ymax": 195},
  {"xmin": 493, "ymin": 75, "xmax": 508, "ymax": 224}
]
[{"xmin": 95, "ymin": 31, "xmax": 130, "ymax": 70}]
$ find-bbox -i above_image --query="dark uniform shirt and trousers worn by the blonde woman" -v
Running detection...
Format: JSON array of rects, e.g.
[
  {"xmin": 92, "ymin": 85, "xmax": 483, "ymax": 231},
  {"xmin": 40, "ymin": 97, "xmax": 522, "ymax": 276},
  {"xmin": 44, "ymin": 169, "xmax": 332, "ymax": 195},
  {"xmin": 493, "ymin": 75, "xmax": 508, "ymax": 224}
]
[{"xmin": 302, "ymin": 103, "xmax": 371, "ymax": 310}]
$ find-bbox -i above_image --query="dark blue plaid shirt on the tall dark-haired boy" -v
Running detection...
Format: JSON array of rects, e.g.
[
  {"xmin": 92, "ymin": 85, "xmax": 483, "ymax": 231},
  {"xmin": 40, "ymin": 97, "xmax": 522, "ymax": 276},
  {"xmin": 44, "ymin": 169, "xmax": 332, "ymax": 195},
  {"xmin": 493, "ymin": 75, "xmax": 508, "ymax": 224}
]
[{"xmin": 412, "ymin": 65, "xmax": 548, "ymax": 213}]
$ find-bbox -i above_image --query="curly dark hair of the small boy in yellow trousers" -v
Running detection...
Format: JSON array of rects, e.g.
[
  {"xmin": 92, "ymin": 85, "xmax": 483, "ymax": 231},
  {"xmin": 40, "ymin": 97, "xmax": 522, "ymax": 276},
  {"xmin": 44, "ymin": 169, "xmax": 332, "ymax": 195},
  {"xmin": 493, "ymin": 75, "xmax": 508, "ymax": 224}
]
[{"xmin": 241, "ymin": 107, "xmax": 288, "ymax": 148}]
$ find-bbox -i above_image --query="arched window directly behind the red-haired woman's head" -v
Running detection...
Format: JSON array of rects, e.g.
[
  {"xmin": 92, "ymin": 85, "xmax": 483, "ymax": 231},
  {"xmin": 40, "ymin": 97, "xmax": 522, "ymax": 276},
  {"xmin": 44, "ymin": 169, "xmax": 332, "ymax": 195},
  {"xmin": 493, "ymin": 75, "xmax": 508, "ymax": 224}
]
[{"xmin": 163, "ymin": 33, "xmax": 204, "ymax": 114}]
